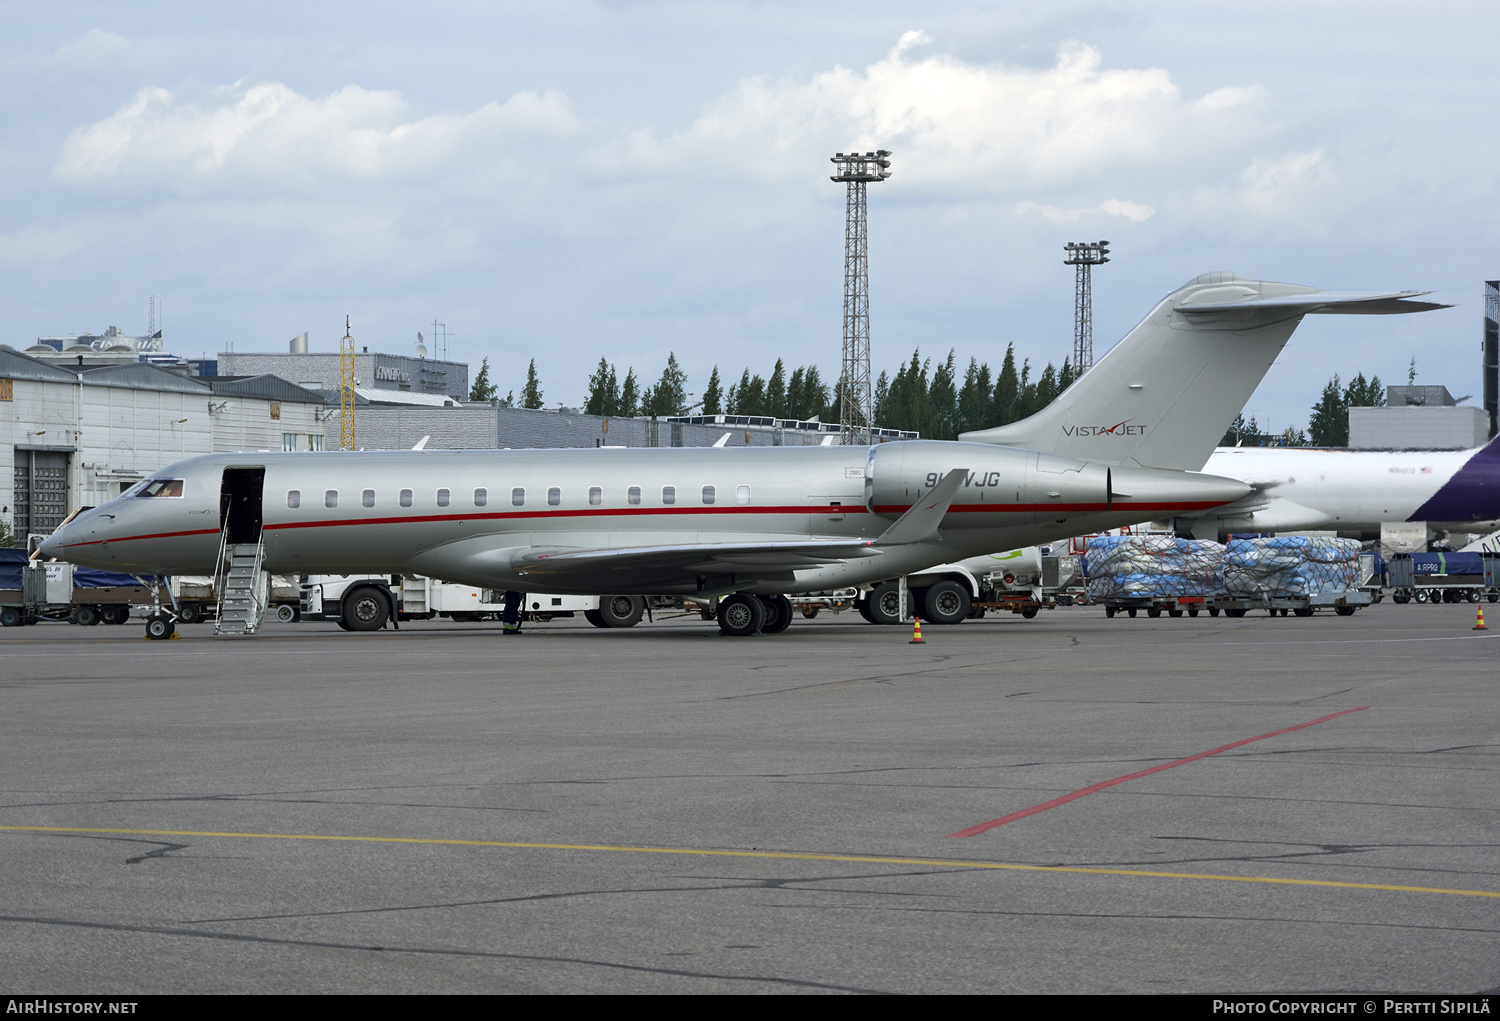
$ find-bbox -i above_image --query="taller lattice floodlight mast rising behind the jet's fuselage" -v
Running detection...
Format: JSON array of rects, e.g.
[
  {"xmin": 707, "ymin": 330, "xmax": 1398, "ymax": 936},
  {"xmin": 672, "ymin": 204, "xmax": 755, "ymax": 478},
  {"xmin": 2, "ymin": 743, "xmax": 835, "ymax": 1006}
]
[{"xmin": 828, "ymin": 148, "xmax": 891, "ymax": 445}]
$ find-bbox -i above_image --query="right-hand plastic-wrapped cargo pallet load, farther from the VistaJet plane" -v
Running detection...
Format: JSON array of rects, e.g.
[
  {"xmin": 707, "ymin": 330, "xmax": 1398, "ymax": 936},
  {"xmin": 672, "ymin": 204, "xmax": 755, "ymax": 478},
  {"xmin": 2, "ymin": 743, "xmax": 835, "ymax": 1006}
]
[{"xmin": 1214, "ymin": 535, "xmax": 1371, "ymax": 616}]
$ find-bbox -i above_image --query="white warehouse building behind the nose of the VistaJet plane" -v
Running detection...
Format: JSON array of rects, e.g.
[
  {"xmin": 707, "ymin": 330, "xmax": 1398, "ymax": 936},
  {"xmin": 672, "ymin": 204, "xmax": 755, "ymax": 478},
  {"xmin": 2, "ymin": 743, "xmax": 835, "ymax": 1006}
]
[{"xmin": 0, "ymin": 346, "xmax": 326, "ymax": 546}]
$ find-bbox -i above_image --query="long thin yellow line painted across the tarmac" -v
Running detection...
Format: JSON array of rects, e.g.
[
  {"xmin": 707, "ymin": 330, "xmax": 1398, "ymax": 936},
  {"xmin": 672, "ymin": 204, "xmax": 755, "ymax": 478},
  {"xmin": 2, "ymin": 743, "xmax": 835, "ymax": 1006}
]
[{"xmin": 0, "ymin": 826, "xmax": 1500, "ymax": 898}]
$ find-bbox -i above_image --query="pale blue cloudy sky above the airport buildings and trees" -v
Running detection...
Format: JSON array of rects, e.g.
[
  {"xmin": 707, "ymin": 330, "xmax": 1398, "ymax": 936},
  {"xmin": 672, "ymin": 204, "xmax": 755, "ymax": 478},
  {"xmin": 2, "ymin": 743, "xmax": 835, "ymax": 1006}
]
[{"xmin": 0, "ymin": 0, "xmax": 1500, "ymax": 430}]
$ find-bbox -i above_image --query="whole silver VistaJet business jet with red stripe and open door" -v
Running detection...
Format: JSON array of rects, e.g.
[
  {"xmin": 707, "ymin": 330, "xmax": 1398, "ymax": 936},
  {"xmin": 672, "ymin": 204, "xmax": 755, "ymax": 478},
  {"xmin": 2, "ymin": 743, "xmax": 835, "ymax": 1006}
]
[{"xmin": 42, "ymin": 274, "xmax": 1437, "ymax": 637}]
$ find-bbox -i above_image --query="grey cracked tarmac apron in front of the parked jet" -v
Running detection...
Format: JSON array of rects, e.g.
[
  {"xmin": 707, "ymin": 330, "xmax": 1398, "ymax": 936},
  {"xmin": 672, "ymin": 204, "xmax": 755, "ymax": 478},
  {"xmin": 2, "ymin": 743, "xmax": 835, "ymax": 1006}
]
[{"xmin": 0, "ymin": 601, "xmax": 1500, "ymax": 994}]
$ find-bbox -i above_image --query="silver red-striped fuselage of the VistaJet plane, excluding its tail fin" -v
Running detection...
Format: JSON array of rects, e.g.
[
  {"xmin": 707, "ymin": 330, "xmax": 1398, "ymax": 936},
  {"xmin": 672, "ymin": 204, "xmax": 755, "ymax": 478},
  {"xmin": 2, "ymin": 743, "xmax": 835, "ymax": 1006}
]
[{"xmin": 44, "ymin": 441, "xmax": 1250, "ymax": 595}]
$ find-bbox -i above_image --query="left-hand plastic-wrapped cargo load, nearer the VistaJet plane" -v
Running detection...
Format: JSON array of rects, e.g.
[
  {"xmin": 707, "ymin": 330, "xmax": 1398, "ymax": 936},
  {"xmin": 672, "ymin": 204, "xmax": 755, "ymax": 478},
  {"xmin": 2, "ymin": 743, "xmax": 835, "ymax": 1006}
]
[{"xmin": 1088, "ymin": 535, "xmax": 1224, "ymax": 600}]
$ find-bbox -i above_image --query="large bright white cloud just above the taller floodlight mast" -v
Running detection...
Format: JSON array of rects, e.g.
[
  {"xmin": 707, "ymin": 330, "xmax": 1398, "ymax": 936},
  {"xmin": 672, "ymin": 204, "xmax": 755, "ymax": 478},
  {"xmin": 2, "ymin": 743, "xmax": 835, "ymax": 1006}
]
[{"xmin": 609, "ymin": 31, "xmax": 1263, "ymax": 193}]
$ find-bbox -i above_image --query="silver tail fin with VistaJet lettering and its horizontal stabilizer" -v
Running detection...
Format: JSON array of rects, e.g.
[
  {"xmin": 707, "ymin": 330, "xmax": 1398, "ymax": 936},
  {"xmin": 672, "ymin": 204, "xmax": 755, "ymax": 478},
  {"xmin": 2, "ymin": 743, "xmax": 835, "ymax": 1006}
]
[{"xmin": 959, "ymin": 273, "xmax": 1449, "ymax": 471}]
